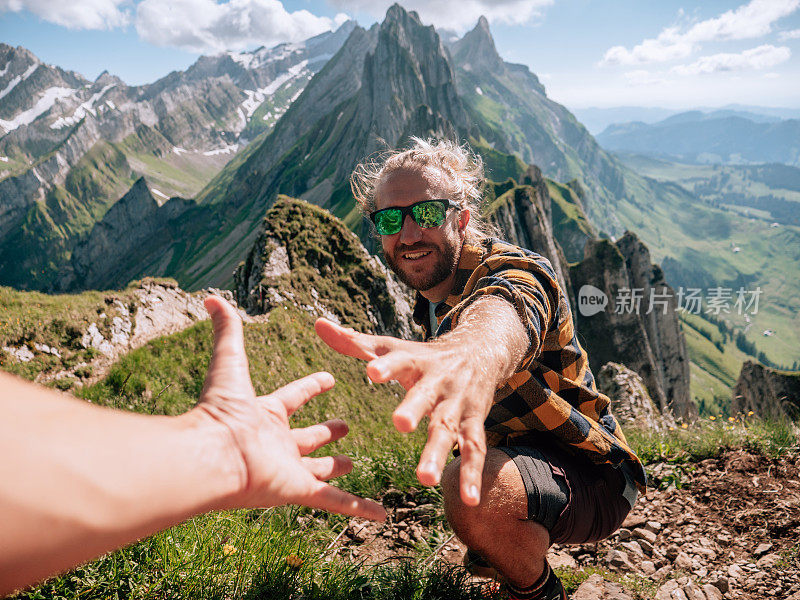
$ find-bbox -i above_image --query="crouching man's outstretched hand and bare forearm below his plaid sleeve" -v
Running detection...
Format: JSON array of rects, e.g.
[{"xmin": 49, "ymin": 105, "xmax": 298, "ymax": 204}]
[{"xmin": 316, "ymin": 296, "xmax": 529, "ymax": 506}]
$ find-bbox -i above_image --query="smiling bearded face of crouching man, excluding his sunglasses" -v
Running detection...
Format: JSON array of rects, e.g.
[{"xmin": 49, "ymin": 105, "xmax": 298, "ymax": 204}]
[{"xmin": 375, "ymin": 169, "xmax": 469, "ymax": 302}]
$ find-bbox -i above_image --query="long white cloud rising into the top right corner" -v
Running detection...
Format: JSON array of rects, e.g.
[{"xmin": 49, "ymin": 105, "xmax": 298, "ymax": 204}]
[{"xmin": 600, "ymin": 0, "xmax": 800, "ymax": 65}]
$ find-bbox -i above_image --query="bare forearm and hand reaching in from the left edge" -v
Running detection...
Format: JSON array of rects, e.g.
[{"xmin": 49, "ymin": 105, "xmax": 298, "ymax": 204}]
[{"xmin": 0, "ymin": 297, "xmax": 385, "ymax": 596}]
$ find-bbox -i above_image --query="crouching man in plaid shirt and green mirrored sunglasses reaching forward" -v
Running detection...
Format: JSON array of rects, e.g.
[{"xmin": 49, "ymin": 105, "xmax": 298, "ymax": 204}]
[{"xmin": 317, "ymin": 138, "xmax": 645, "ymax": 600}]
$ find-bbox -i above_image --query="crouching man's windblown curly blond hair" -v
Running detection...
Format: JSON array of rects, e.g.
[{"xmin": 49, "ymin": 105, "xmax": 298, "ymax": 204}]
[{"xmin": 350, "ymin": 137, "xmax": 497, "ymax": 243}]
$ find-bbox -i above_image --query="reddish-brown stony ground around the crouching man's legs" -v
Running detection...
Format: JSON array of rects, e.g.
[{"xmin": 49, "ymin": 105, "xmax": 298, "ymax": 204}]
[{"xmin": 333, "ymin": 450, "xmax": 800, "ymax": 600}]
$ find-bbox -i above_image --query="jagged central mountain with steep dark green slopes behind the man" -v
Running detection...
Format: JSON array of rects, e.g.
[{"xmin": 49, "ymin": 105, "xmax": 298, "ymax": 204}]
[{"xmin": 54, "ymin": 5, "xmax": 636, "ymax": 288}]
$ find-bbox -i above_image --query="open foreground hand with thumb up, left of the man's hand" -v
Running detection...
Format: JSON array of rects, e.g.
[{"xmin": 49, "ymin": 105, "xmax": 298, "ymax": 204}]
[{"xmin": 192, "ymin": 296, "xmax": 386, "ymax": 519}]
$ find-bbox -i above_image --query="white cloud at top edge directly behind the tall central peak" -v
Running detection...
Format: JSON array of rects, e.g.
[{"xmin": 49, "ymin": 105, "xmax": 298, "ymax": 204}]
[{"xmin": 330, "ymin": 0, "xmax": 554, "ymax": 33}]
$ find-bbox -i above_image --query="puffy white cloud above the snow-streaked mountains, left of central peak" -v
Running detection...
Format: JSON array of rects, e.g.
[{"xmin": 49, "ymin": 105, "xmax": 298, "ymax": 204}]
[{"xmin": 134, "ymin": 0, "xmax": 347, "ymax": 53}]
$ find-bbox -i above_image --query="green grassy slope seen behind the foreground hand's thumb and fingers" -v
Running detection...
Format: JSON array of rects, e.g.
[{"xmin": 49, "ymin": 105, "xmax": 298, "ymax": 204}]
[{"xmin": 76, "ymin": 306, "xmax": 424, "ymax": 453}]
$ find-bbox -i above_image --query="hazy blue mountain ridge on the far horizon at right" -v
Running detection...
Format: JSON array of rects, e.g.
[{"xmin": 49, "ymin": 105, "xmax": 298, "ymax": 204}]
[{"xmin": 597, "ymin": 110, "xmax": 800, "ymax": 166}]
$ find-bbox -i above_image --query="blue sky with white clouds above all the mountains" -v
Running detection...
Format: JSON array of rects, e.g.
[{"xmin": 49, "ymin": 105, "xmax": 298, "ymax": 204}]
[{"xmin": 0, "ymin": 0, "xmax": 800, "ymax": 108}]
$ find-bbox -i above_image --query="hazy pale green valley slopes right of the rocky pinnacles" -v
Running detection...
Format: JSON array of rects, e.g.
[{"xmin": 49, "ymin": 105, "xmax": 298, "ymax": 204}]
[{"xmin": 615, "ymin": 165, "xmax": 800, "ymax": 366}]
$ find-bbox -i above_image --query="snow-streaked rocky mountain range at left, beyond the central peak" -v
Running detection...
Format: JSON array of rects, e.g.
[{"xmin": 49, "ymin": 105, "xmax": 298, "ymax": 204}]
[{"xmin": 0, "ymin": 21, "xmax": 355, "ymax": 288}]
